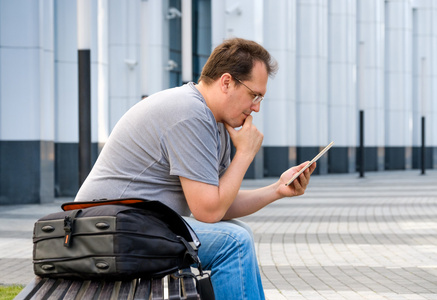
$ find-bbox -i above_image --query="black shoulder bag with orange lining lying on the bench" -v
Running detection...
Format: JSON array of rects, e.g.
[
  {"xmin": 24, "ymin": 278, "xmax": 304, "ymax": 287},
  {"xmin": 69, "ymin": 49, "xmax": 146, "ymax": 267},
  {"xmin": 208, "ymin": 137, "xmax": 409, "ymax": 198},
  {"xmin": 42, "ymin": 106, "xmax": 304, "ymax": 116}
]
[{"xmin": 33, "ymin": 199, "xmax": 212, "ymax": 299}]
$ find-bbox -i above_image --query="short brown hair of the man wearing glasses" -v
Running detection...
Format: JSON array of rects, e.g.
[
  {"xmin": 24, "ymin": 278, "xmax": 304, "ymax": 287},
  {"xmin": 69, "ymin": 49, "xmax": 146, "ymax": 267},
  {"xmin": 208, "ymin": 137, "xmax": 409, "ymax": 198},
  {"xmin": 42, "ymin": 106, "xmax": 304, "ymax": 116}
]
[{"xmin": 199, "ymin": 38, "xmax": 278, "ymax": 85}]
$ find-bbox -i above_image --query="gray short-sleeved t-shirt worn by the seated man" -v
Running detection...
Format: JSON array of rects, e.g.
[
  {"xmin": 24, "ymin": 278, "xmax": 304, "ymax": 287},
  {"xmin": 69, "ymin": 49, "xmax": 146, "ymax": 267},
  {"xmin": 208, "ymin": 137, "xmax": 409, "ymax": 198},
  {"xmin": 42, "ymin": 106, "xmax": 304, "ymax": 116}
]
[{"xmin": 75, "ymin": 83, "xmax": 230, "ymax": 216}]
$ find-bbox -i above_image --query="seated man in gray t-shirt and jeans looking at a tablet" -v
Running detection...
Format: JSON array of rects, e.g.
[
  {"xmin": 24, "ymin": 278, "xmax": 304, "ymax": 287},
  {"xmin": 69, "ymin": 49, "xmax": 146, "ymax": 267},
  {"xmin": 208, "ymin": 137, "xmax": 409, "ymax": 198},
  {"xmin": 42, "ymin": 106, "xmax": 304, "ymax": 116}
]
[{"xmin": 76, "ymin": 38, "xmax": 315, "ymax": 300}]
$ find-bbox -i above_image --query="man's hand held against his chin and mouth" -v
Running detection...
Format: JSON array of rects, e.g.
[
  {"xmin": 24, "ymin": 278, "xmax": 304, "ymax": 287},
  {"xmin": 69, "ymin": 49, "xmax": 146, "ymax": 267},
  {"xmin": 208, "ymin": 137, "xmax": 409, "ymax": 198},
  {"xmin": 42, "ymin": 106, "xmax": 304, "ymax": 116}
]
[{"xmin": 225, "ymin": 116, "xmax": 264, "ymax": 158}]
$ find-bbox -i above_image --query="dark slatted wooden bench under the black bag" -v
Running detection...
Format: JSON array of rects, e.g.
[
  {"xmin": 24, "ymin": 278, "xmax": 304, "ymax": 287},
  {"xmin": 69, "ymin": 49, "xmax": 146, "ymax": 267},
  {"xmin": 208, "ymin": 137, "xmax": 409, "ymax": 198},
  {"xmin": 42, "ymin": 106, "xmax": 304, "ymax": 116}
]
[{"xmin": 15, "ymin": 275, "xmax": 200, "ymax": 300}]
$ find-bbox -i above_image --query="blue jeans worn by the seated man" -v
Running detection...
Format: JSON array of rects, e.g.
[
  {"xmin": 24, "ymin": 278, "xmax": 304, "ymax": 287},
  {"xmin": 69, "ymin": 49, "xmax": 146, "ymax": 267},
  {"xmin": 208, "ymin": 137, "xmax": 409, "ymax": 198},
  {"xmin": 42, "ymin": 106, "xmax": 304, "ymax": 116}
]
[{"xmin": 185, "ymin": 218, "xmax": 265, "ymax": 300}]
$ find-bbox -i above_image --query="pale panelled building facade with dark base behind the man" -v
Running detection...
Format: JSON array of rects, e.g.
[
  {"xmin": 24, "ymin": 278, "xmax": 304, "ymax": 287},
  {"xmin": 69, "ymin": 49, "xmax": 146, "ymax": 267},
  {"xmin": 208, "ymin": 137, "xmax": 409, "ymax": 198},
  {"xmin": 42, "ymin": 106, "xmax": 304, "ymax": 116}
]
[{"xmin": 0, "ymin": 0, "xmax": 437, "ymax": 204}]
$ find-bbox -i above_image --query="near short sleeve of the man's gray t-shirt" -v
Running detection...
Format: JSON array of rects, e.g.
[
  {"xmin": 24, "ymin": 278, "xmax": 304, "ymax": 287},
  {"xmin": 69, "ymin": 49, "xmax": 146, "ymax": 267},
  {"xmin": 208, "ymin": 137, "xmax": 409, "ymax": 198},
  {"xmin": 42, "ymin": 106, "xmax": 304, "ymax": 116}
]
[{"xmin": 161, "ymin": 118, "xmax": 220, "ymax": 186}]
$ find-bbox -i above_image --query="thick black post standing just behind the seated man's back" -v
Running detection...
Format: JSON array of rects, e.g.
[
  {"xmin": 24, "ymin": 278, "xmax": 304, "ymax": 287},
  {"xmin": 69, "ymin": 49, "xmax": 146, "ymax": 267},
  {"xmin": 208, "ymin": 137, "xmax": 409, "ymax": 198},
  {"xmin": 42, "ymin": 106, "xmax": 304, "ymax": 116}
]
[{"xmin": 78, "ymin": 49, "xmax": 91, "ymax": 187}]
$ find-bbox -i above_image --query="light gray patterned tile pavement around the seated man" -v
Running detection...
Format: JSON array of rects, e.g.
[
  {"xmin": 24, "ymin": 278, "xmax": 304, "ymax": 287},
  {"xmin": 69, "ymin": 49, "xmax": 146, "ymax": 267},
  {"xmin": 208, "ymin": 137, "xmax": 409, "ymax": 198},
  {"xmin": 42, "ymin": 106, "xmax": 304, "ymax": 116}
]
[{"xmin": 0, "ymin": 170, "xmax": 437, "ymax": 300}]
